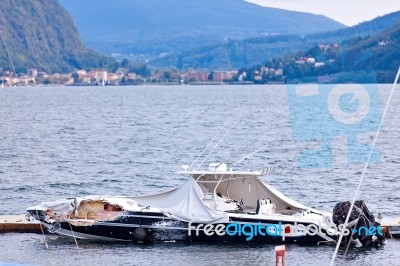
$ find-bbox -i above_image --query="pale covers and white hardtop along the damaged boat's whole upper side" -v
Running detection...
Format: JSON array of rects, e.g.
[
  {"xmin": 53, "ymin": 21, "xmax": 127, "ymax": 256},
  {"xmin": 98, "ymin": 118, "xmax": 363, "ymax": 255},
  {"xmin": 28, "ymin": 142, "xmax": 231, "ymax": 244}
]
[{"xmin": 28, "ymin": 168, "xmax": 323, "ymax": 223}]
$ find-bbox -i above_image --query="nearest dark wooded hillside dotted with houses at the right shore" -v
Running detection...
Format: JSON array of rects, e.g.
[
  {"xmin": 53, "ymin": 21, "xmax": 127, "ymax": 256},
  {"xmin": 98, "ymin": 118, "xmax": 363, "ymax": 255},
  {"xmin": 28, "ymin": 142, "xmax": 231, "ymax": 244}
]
[{"xmin": 247, "ymin": 23, "xmax": 400, "ymax": 83}]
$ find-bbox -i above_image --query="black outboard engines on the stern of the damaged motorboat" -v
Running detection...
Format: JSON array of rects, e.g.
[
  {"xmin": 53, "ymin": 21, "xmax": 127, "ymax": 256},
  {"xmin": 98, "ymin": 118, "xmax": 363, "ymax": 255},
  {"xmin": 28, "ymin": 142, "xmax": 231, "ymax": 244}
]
[{"xmin": 332, "ymin": 200, "xmax": 385, "ymax": 246}]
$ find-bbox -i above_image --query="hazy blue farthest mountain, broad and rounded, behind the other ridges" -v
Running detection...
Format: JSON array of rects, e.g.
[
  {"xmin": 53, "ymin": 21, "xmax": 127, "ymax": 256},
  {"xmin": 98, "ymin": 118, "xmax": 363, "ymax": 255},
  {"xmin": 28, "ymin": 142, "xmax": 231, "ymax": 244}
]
[{"xmin": 60, "ymin": 0, "xmax": 344, "ymax": 56}]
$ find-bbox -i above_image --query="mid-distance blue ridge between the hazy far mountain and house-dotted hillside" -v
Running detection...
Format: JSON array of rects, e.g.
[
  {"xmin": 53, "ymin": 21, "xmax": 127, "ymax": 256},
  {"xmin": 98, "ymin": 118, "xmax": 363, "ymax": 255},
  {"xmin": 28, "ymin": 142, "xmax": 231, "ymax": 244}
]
[{"xmin": 151, "ymin": 12, "xmax": 400, "ymax": 70}]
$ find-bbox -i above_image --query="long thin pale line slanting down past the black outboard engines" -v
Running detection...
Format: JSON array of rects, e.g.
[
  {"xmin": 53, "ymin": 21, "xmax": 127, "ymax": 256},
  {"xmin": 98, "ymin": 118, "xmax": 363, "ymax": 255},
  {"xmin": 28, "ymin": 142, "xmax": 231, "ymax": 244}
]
[{"xmin": 330, "ymin": 67, "xmax": 400, "ymax": 266}]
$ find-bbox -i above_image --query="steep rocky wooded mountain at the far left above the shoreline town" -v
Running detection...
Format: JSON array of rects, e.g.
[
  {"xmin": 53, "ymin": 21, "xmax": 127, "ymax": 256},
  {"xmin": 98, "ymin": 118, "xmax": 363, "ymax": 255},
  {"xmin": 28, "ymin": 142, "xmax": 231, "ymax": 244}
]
[{"xmin": 0, "ymin": 0, "xmax": 113, "ymax": 72}]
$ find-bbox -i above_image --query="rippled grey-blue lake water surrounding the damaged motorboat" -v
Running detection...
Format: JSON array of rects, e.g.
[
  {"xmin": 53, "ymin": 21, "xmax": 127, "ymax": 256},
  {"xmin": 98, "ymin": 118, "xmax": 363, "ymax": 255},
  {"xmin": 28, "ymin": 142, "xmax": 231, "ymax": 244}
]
[{"xmin": 0, "ymin": 85, "xmax": 400, "ymax": 266}]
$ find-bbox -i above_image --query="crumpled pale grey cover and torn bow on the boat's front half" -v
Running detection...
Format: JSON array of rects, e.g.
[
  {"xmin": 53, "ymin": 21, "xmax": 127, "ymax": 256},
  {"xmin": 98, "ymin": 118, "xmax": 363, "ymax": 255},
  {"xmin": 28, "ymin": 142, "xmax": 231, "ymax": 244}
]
[{"xmin": 28, "ymin": 179, "xmax": 229, "ymax": 223}]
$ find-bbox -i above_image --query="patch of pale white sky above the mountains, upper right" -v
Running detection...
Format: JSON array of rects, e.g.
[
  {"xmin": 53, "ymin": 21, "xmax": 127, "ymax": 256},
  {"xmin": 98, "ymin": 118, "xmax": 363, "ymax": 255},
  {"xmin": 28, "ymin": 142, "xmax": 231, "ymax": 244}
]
[{"xmin": 247, "ymin": 0, "xmax": 400, "ymax": 26}]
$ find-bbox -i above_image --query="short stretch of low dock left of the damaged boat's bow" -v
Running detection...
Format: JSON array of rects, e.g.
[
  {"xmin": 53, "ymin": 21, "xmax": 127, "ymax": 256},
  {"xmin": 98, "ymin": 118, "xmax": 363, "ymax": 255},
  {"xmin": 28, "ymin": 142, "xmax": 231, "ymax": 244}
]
[{"xmin": 0, "ymin": 215, "xmax": 47, "ymax": 234}]
